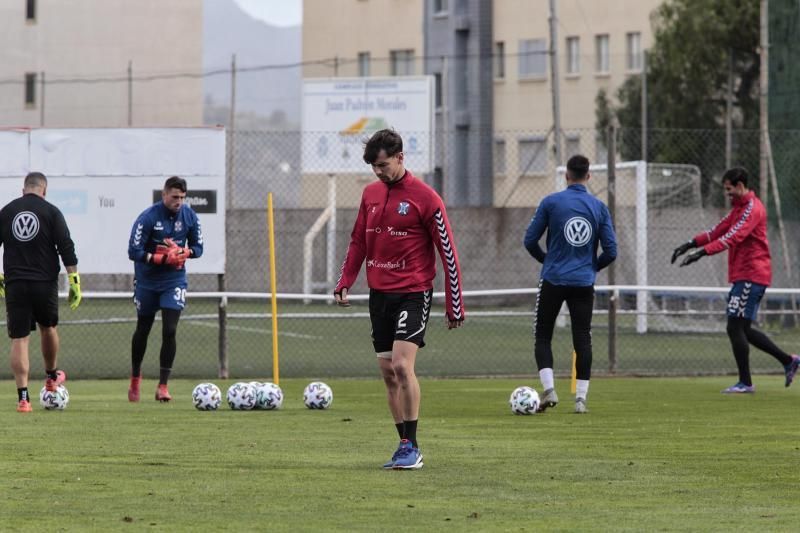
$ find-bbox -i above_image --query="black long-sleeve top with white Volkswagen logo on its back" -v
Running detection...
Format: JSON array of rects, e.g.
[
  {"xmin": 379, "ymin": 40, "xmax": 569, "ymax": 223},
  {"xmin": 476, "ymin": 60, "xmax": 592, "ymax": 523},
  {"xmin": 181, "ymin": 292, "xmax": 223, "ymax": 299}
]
[{"xmin": 0, "ymin": 193, "xmax": 78, "ymax": 282}]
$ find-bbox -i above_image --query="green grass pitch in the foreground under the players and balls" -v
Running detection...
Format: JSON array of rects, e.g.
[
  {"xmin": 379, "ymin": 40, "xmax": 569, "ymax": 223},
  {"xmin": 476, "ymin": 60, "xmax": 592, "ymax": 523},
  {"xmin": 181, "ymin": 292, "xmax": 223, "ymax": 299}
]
[{"xmin": 0, "ymin": 376, "xmax": 800, "ymax": 531}]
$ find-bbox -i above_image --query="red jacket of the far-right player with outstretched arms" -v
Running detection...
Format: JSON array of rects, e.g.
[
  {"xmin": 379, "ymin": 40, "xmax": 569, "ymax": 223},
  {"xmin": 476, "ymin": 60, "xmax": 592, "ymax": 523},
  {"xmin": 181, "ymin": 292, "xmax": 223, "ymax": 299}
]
[{"xmin": 694, "ymin": 191, "xmax": 772, "ymax": 285}]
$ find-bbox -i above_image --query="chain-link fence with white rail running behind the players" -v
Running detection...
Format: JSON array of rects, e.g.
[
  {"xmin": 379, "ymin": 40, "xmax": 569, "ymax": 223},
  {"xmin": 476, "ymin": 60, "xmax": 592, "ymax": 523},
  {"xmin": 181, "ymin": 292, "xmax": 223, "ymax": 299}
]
[{"xmin": 0, "ymin": 129, "xmax": 800, "ymax": 378}]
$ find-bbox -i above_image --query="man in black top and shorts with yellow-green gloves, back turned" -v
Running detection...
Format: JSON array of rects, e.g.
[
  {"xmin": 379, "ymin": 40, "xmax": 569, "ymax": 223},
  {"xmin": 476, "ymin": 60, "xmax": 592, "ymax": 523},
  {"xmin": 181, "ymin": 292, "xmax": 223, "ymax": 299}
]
[{"xmin": 0, "ymin": 172, "xmax": 81, "ymax": 413}]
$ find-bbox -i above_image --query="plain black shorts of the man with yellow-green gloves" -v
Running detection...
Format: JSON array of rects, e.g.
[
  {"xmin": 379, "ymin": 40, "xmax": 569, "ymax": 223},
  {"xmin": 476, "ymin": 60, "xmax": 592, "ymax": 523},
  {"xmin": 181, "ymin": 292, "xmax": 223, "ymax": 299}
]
[{"xmin": 6, "ymin": 280, "xmax": 58, "ymax": 339}]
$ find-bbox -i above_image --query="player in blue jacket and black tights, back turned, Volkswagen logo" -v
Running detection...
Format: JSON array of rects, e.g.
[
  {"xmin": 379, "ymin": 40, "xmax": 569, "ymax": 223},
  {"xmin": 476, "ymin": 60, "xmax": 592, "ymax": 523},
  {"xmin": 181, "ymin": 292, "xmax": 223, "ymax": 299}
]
[{"xmin": 525, "ymin": 155, "xmax": 617, "ymax": 413}]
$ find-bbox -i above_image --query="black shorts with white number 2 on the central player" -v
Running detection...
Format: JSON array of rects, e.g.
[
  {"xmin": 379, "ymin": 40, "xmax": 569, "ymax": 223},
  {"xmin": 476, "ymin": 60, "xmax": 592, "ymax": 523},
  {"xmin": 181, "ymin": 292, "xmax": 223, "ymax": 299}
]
[{"xmin": 369, "ymin": 289, "xmax": 433, "ymax": 356}]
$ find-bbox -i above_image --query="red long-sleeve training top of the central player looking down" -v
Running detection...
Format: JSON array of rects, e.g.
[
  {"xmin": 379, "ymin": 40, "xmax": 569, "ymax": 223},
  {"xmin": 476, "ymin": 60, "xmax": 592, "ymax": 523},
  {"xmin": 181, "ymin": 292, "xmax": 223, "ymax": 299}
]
[{"xmin": 335, "ymin": 170, "xmax": 465, "ymax": 320}]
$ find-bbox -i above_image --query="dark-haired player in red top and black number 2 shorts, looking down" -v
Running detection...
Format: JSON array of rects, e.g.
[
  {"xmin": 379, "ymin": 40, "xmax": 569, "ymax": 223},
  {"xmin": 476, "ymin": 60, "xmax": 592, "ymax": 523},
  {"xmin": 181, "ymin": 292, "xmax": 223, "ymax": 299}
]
[{"xmin": 333, "ymin": 129, "xmax": 464, "ymax": 470}]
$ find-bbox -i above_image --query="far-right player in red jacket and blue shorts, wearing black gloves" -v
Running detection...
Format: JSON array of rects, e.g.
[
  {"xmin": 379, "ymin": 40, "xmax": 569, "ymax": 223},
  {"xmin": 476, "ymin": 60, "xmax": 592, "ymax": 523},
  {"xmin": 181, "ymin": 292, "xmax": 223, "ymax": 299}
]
[{"xmin": 671, "ymin": 167, "xmax": 800, "ymax": 394}]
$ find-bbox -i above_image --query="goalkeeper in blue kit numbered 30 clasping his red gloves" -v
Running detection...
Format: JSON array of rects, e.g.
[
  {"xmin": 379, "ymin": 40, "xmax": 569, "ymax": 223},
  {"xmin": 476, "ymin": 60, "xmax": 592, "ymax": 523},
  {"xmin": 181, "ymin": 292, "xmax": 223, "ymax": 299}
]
[{"xmin": 128, "ymin": 176, "xmax": 203, "ymax": 402}]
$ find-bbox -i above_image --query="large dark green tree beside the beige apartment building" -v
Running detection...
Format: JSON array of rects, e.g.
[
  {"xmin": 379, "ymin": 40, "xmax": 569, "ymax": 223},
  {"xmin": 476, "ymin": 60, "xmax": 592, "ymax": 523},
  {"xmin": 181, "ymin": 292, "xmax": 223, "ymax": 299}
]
[{"xmin": 614, "ymin": 0, "xmax": 760, "ymax": 197}]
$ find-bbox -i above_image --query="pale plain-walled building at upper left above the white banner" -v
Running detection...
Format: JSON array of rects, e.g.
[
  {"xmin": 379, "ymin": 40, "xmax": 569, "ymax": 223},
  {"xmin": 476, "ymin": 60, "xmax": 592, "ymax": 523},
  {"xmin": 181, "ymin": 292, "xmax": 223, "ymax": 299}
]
[{"xmin": 0, "ymin": 0, "xmax": 203, "ymax": 127}]
